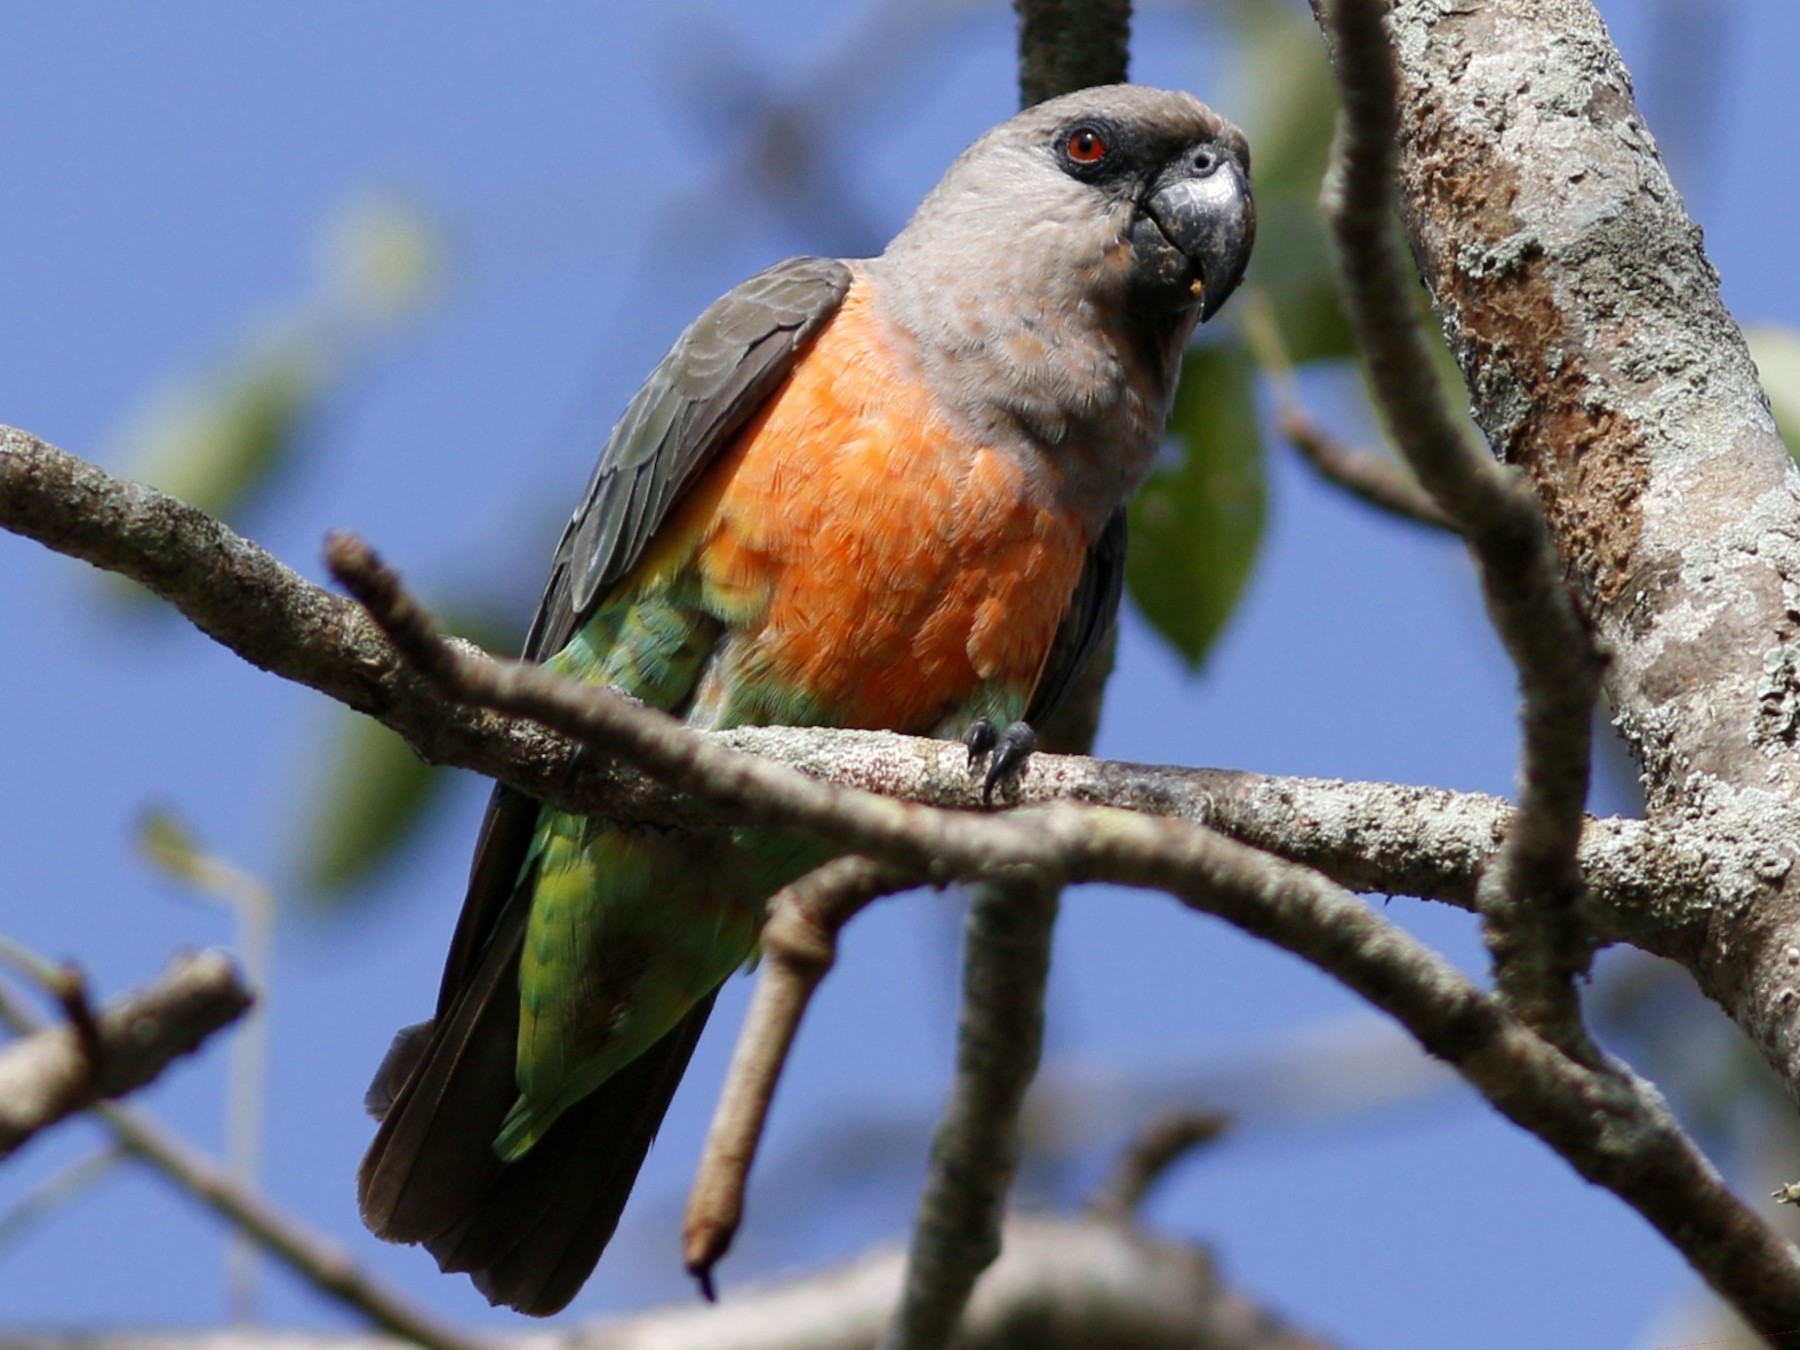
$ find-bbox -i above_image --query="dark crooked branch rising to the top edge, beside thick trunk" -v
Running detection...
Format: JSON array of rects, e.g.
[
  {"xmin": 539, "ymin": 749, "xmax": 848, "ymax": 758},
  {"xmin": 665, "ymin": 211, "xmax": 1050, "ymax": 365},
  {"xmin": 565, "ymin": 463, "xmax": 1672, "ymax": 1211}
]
[{"xmin": 1316, "ymin": 0, "xmax": 1602, "ymax": 1064}]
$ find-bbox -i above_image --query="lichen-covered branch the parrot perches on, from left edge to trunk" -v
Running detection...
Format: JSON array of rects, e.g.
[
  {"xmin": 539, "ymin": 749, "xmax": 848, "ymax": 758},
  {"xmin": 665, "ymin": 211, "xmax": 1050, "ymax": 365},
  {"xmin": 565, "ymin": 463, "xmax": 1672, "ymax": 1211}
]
[{"xmin": 0, "ymin": 428, "xmax": 1648, "ymax": 928}]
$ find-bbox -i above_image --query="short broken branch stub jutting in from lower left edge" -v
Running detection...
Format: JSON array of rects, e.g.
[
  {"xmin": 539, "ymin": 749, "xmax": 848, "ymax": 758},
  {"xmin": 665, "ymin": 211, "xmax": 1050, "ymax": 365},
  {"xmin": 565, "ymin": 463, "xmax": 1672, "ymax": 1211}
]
[{"xmin": 0, "ymin": 952, "xmax": 252, "ymax": 1157}]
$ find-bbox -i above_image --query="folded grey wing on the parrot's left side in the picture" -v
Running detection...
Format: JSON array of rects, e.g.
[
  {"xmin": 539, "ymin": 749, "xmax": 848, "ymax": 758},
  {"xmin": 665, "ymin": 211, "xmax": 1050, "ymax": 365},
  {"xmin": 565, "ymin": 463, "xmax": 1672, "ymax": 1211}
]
[{"xmin": 526, "ymin": 257, "xmax": 851, "ymax": 657}]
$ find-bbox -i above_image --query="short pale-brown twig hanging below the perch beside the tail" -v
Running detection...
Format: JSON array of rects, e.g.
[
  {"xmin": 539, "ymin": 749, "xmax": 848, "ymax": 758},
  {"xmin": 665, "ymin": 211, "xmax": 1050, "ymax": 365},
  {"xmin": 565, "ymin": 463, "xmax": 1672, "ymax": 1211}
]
[{"xmin": 682, "ymin": 857, "xmax": 914, "ymax": 1301}]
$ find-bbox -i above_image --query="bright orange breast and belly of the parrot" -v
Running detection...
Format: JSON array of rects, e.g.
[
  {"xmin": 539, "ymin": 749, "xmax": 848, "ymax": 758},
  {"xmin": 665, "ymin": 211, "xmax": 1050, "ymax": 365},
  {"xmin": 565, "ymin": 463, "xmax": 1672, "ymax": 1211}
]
[{"xmin": 646, "ymin": 284, "xmax": 1087, "ymax": 733}]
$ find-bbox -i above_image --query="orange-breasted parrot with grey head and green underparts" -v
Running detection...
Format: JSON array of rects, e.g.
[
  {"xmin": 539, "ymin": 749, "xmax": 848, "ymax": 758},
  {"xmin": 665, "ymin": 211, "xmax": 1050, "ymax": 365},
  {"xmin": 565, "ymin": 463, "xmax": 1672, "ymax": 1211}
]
[{"xmin": 358, "ymin": 85, "xmax": 1255, "ymax": 1316}]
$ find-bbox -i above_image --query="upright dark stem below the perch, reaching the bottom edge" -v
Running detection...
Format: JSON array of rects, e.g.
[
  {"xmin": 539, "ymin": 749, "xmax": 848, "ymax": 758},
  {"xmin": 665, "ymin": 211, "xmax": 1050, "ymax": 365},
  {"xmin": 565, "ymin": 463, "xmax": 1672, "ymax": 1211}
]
[{"xmin": 882, "ymin": 873, "xmax": 1062, "ymax": 1350}]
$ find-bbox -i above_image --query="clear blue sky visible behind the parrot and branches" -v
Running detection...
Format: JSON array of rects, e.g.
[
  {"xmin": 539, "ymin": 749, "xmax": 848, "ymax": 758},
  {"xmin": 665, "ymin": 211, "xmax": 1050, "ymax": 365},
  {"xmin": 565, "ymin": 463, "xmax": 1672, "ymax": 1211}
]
[{"xmin": 0, "ymin": 0, "xmax": 1800, "ymax": 1348}]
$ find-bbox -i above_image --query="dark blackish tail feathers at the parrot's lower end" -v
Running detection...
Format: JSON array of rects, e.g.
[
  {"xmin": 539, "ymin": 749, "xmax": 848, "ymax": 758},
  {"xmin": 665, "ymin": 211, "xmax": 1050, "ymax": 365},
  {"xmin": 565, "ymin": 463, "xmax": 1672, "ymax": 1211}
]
[{"xmin": 358, "ymin": 905, "xmax": 713, "ymax": 1316}]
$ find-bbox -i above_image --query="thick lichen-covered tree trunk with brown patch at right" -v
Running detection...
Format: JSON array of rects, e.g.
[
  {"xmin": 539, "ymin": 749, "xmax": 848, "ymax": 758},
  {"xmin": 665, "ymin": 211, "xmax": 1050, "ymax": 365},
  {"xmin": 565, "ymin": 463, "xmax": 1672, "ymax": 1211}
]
[{"xmin": 1353, "ymin": 0, "xmax": 1800, "ymax": 1094}]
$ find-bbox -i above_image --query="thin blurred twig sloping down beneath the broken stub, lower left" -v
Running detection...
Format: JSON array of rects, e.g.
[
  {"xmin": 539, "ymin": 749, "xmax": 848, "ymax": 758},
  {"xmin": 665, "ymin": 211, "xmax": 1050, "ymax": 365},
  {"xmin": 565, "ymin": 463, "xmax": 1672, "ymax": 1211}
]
[{"xmin": 0, "ymin": 986, "xmax": 486, "ymax": 1350}]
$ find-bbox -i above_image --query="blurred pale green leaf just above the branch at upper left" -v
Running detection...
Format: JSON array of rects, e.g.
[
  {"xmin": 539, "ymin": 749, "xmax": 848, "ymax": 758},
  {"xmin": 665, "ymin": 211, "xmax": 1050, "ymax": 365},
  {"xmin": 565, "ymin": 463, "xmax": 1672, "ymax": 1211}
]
[{"xmin": 112, "ymin": 333, "xmax": 326, "ymax": 520}]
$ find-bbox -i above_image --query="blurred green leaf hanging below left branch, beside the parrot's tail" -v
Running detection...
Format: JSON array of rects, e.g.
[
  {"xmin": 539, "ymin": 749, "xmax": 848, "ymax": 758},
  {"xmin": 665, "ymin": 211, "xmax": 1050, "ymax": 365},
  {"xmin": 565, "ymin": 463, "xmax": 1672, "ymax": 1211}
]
[{"xmin": 301, "ymin": 709, "xmax": 450, "ymax": 898}]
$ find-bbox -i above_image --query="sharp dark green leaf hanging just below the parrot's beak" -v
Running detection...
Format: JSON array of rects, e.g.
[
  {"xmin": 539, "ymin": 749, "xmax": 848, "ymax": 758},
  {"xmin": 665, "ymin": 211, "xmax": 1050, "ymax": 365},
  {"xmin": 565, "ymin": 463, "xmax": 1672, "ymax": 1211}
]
[{"xmin": 1125, "ymin": 344, "xmax": 1267, "ymax": 670}]
